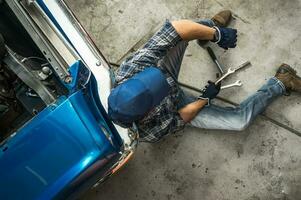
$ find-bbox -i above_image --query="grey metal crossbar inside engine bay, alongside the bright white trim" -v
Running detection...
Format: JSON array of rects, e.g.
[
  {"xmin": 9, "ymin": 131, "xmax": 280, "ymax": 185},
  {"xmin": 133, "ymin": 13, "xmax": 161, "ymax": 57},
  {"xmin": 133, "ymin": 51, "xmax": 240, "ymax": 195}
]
[{"xmin": 6, "ymin": 0, "xmax": 79, "ymax": 81}]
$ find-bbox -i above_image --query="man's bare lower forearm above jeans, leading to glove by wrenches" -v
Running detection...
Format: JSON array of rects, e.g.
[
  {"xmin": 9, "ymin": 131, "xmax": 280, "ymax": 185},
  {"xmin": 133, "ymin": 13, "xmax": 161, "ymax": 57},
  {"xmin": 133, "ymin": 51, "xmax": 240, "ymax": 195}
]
[{"xmin": 178, "ymin": 99, "xmax": 208, "ymax": 123}]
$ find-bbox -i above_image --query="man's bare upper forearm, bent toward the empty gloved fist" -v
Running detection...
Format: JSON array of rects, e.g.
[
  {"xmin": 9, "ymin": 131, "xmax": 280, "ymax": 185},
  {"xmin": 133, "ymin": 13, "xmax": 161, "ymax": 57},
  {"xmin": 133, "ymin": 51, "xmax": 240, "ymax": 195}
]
[{"xmin": 171, "ymin": 20, "xmax": 216, "ymax": 41}]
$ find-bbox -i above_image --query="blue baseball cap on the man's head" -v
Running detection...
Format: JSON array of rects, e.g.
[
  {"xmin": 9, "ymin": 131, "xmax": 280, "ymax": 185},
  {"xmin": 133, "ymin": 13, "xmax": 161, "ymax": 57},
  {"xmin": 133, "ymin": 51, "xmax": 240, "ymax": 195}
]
[{"xmin": 108, "ymin": 67, "xmax": 170, "ymax": 126}]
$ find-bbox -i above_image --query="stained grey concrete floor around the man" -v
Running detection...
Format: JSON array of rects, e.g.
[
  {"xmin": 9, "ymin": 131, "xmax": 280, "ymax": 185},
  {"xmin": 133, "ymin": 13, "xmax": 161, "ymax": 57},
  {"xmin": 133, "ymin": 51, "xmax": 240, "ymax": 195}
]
[{"xmin": 66, "ymin": 0, "xmax": 301, "ymax": 200}]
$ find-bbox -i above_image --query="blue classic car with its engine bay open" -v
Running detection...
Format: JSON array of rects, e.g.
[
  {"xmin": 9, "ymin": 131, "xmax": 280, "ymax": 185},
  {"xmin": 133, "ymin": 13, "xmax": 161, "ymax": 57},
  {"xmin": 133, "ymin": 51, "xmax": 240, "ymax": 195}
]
[{"xmin": 0, "ymin": 0, "xmax": 137, "ymax": 200}]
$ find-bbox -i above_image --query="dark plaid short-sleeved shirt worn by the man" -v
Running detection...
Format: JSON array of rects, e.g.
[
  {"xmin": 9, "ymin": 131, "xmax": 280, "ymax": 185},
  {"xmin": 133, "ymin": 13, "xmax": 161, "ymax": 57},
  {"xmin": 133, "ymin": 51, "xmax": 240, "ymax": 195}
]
[{"xmin": 115, "ymin": 21, "xmax": 184, "ymax": 142}]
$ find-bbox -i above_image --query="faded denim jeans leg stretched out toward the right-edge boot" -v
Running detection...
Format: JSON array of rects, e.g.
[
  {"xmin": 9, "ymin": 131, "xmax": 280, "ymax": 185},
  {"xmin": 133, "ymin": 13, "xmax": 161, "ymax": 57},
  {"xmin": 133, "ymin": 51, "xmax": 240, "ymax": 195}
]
[{"xmin": 190, "ymin": 78, "xmax": 285, "ymax": 131}]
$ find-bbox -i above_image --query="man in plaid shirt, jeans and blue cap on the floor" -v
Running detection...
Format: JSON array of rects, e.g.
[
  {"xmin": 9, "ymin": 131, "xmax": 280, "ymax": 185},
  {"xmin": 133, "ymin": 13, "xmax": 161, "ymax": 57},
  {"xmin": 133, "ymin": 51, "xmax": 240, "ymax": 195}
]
[{"xmin": 108, "ymin": 11, "xmax": 301, "ymax": 142}]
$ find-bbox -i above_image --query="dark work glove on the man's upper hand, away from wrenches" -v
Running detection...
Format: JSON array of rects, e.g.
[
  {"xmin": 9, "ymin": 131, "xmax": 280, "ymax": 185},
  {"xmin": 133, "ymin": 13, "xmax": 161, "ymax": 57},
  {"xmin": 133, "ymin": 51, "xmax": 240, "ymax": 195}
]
[{"xmin": 212, "ymin": 26, "xmax": 237, "ymax": 49}]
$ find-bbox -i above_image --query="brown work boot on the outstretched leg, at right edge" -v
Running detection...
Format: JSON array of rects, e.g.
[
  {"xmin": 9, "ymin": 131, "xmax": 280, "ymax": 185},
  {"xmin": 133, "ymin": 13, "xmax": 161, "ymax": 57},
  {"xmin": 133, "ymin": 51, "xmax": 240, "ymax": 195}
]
[{"xmin": 275, "ymin": 63, "xmax": 301, "ymax": 93}]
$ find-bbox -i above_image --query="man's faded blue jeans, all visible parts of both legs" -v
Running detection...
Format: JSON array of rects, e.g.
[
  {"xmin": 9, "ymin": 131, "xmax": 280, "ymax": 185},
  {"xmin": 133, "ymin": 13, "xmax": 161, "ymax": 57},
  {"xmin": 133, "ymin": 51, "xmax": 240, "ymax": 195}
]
[{"xmin": 161, "ymin": 20, "xmax": 285, "ymax": 131}]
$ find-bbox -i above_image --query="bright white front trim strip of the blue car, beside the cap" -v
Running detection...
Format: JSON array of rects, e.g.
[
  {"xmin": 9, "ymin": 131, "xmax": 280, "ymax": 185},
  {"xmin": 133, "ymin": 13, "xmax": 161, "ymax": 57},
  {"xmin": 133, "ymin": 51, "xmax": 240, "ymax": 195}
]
[{"xmin": 43, "ymin": 0, "xmax": 131, "ymax": 144}]
